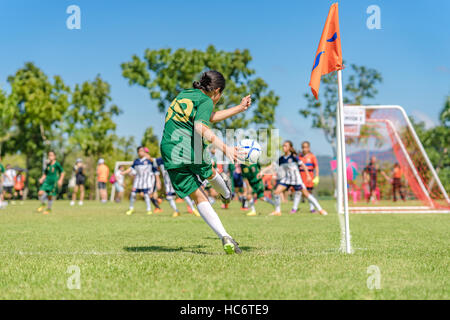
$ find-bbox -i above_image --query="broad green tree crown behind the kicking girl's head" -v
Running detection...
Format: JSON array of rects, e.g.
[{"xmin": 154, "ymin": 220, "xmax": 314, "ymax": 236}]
[{"xmin": 121, "ymin": 45, "xmax": 279, "ymax": 130}]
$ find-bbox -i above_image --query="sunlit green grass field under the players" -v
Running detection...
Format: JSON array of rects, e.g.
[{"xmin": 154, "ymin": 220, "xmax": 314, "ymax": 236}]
[{"xmin": 0, "ymin": 201, "xmax": 450, "ymax": 299}]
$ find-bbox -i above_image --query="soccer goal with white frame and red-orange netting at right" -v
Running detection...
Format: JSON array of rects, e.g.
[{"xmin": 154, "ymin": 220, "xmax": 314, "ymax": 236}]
[{"xmin": 344, "ymin": 105, "xmax": 450, "ymax": 213}]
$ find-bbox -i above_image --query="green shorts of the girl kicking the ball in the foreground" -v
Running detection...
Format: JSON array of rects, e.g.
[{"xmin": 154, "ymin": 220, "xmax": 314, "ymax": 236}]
[{"xmin": 167, "ymin": 163, "xmax": 213, "ymax": 198}]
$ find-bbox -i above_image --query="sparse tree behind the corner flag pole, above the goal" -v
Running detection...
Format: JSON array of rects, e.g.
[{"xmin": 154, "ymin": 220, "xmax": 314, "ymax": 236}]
[{"xmin": 300, "ymin": 64, "xmax": 382, "ymax": 156}]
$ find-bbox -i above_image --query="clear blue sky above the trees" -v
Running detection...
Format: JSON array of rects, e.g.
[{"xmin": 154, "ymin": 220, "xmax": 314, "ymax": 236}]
[{"xmin": 0, "ymin": 0, "xmax": 450, "ymax": 154}]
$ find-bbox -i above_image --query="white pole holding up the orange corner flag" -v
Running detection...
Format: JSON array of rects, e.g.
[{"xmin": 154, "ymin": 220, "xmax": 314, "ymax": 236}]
[{"xmin": 336, "ymin": 70, "xmax": 352, "ymax": 253}]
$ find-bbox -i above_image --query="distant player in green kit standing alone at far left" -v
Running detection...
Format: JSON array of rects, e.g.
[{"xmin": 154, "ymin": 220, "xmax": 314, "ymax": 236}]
[{"xmin": 38, "ymin": 151, "xmax": 64, "ymax": 214}]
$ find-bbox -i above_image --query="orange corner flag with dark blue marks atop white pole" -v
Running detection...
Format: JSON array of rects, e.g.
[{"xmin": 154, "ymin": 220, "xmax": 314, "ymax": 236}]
[{"xmin": 309, "ymin": 3, "xmax": 342, "ymax": 99}]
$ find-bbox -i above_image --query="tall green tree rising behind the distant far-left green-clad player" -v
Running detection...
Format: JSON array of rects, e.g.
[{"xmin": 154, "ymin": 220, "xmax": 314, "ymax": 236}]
[{"xmin": 5, "ymin": 62, "xmax": 70, "ymax": 195}]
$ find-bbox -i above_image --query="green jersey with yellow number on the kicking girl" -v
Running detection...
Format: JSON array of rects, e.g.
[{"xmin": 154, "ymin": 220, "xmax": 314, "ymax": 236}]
[{"xmin": 161, "ymin": 89, "xmax": 214, "ymax": 169}]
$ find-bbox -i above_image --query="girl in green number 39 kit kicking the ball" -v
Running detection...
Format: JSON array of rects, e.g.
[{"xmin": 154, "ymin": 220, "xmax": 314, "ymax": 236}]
[{"xmin": 161, "ymin": 70, "xmax": 251, "ymax": 254}]
